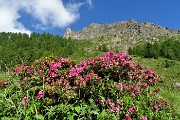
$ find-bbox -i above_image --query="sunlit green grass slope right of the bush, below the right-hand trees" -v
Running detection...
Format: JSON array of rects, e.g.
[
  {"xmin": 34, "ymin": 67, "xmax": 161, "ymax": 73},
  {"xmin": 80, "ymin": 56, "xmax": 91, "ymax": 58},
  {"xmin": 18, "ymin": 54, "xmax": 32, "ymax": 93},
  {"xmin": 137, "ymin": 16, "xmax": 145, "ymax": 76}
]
[{"xmin": 133, "ymin": 57, "xmax": 180, "ymax": 113}]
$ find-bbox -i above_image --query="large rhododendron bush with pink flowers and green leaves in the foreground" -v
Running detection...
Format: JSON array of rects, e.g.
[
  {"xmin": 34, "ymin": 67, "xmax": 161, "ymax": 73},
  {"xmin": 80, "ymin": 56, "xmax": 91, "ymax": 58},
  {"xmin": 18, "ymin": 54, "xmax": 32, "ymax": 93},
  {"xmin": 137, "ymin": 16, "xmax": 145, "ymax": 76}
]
[{"xmin": 15, "ymin": 51, "xmax": 171, "ymax": 120}]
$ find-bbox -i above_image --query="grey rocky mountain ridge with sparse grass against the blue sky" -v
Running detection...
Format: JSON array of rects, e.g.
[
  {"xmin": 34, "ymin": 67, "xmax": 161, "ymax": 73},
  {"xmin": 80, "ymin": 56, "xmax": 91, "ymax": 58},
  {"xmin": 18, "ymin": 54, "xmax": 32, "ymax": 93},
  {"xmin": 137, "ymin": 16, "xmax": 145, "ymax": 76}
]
[{"xmin": 64, "ymin": 19, "xmax": 180, "ymax": 51}]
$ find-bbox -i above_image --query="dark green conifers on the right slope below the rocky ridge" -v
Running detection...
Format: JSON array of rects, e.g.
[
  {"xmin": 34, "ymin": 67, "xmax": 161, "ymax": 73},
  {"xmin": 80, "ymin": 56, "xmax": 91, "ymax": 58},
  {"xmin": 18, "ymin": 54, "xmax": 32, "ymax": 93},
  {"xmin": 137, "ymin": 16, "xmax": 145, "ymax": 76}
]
[{"xmin": 128, "ymin": 38, "xmax": 180, "ymax": 60}]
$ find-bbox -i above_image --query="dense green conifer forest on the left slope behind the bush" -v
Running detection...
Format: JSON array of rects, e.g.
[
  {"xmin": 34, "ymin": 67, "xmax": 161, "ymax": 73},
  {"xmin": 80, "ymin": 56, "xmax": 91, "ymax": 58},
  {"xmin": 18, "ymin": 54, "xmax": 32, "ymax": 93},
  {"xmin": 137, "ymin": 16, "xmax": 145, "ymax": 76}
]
[{"xmin": 0, "ymin": 32, "xmax": 92, "ymax": 68}]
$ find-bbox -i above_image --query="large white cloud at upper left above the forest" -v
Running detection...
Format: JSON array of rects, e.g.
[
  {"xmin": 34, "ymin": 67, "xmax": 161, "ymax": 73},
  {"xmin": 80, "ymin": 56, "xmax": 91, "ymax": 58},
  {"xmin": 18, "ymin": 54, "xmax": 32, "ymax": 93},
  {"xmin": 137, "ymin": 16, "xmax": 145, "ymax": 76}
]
[{"xmin": 0, "ymin": 0, "xmax": 92, "ymax": 34}]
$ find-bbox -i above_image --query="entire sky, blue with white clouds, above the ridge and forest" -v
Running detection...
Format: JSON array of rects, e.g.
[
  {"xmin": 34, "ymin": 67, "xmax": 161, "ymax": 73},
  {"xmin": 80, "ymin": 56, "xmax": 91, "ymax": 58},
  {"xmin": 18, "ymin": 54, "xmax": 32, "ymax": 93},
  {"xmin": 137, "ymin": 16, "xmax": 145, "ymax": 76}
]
[{"xmin": 0, "ymin": 0, "xmax": 180, "ymax": 35}]
